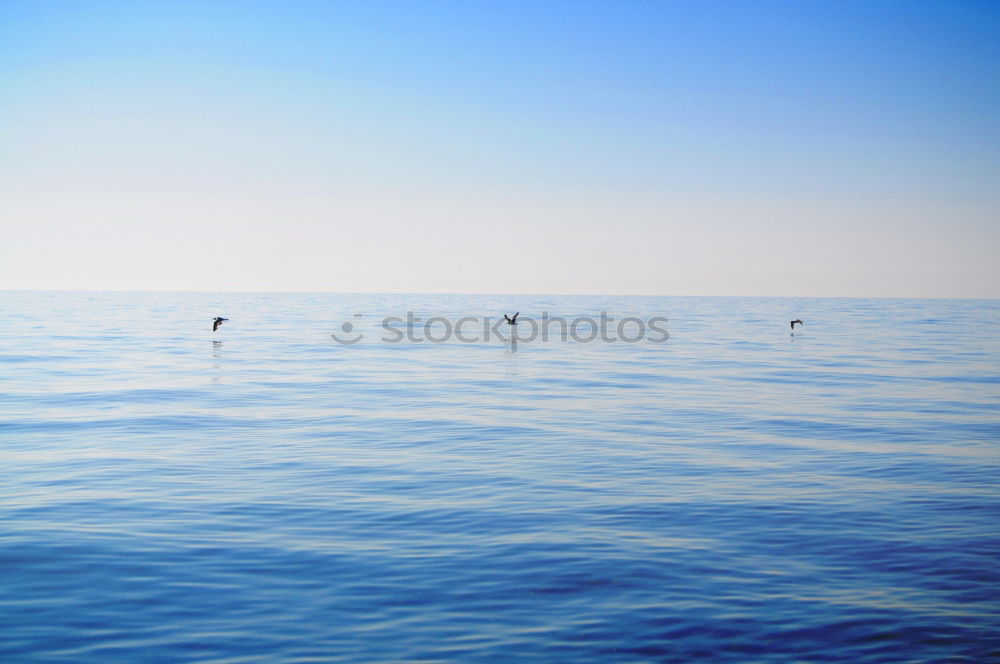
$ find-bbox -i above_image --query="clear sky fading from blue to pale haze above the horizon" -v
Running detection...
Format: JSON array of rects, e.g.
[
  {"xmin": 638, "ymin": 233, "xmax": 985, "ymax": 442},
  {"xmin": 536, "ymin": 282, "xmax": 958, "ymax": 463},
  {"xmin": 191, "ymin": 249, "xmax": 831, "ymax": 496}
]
[{"xmin": 0, "ymin": 0, "xmax": 1000, "ymax": 298}]
